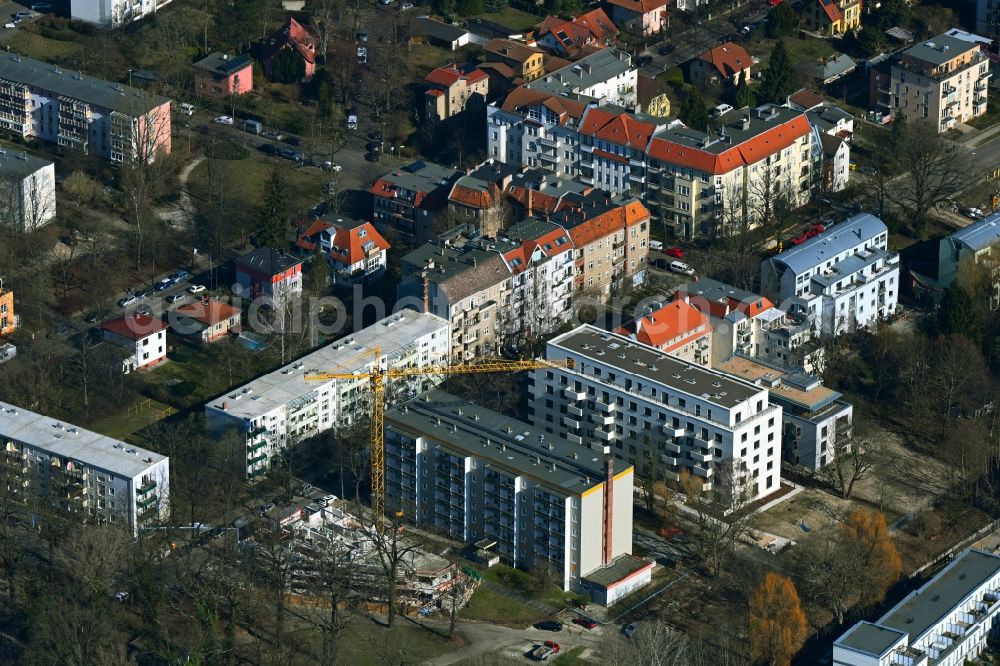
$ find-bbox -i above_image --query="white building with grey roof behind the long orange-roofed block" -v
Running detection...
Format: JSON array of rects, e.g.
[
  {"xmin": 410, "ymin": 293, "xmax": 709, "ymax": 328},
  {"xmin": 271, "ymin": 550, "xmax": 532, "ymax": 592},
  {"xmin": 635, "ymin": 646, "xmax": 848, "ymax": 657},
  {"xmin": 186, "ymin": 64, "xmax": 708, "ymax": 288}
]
[{"xmin": 524, "ymin": 49, "xmax": 638, "ymax": 108}]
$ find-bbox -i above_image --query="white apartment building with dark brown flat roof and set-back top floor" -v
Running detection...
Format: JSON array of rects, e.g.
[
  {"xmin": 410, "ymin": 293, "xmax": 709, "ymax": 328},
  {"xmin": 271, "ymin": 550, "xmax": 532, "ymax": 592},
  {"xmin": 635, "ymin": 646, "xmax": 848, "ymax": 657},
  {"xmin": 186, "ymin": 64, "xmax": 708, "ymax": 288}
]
[{"xmin": 528, "ymin": 325, "xmax": 782, "ymax": 499}]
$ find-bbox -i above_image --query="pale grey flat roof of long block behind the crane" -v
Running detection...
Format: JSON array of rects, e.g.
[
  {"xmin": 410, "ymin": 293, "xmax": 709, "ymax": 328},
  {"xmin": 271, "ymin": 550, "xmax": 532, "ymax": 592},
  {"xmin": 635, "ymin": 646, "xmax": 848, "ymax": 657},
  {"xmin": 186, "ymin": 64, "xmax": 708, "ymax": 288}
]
[{"xmin": 207, "ymin": 310, "xmax": 448, "ymax": 419}]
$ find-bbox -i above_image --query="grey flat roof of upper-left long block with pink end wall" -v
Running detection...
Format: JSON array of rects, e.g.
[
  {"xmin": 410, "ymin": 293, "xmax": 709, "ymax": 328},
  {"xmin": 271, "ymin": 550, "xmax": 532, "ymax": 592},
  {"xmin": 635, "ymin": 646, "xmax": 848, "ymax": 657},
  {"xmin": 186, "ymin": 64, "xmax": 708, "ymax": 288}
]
[{"xmin": 0, "ymin": 53, "xmax": 170, "ymax": 115}]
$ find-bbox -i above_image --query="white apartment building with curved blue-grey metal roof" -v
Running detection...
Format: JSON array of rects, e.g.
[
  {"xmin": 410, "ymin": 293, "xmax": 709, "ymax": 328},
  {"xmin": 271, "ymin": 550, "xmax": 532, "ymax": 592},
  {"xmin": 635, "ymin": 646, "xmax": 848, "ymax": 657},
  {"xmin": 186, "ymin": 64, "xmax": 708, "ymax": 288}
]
[{"xmin": 760, "ymin": 213, "xmax": 899, "ymax": 336}]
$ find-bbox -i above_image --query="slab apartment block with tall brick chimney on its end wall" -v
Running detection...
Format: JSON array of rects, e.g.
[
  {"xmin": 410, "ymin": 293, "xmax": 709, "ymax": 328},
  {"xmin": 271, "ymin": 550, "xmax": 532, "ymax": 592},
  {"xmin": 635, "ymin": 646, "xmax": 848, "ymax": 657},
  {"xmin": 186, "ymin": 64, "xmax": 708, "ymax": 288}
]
[{"xmin": 385, "ymin": 390, "xmax": 633, "ymax": 590}]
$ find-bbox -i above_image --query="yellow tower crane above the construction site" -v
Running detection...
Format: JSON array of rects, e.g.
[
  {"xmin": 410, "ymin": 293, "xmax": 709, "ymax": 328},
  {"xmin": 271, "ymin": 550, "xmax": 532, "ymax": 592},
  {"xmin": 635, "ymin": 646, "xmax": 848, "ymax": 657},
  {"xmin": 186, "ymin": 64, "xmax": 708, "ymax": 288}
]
[{"xmin": 306, "ymin": 347, "xmax": 573, "ymax": 525}]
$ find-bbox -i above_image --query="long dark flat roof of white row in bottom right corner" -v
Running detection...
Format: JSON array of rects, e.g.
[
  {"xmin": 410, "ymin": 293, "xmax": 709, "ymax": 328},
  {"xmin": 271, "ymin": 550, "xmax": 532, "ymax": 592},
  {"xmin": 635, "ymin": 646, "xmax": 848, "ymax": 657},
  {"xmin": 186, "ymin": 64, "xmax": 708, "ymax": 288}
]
[{"xmin": 878, "ymin": 548, "xmax": 1000, "ymax": 642}]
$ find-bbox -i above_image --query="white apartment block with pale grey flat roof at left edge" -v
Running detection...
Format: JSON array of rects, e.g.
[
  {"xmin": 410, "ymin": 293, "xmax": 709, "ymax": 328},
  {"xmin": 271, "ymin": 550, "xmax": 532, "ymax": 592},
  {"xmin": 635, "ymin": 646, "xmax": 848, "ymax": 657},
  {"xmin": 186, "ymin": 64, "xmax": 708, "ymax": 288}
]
[{"xmin": 0, "ymin": 402, "xmax": 170, "ymax": 534}]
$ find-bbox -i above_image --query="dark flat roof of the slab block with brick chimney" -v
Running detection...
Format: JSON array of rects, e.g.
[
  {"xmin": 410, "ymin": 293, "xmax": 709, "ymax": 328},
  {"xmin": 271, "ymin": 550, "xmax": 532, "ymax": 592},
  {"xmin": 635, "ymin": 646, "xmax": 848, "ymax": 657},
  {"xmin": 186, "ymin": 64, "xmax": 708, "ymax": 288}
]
[{"xmin": 385, "ymin": 389, "xmax": 632, "ymax": 495}]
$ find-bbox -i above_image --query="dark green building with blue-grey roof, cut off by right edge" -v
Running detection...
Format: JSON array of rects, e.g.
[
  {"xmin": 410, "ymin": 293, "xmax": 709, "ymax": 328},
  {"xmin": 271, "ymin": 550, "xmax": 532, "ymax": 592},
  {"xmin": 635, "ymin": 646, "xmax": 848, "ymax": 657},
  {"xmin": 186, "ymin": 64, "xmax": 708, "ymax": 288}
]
[{"xmin": 910, "ymin": 213, "xmax": 1000, "ymax": 305}]
